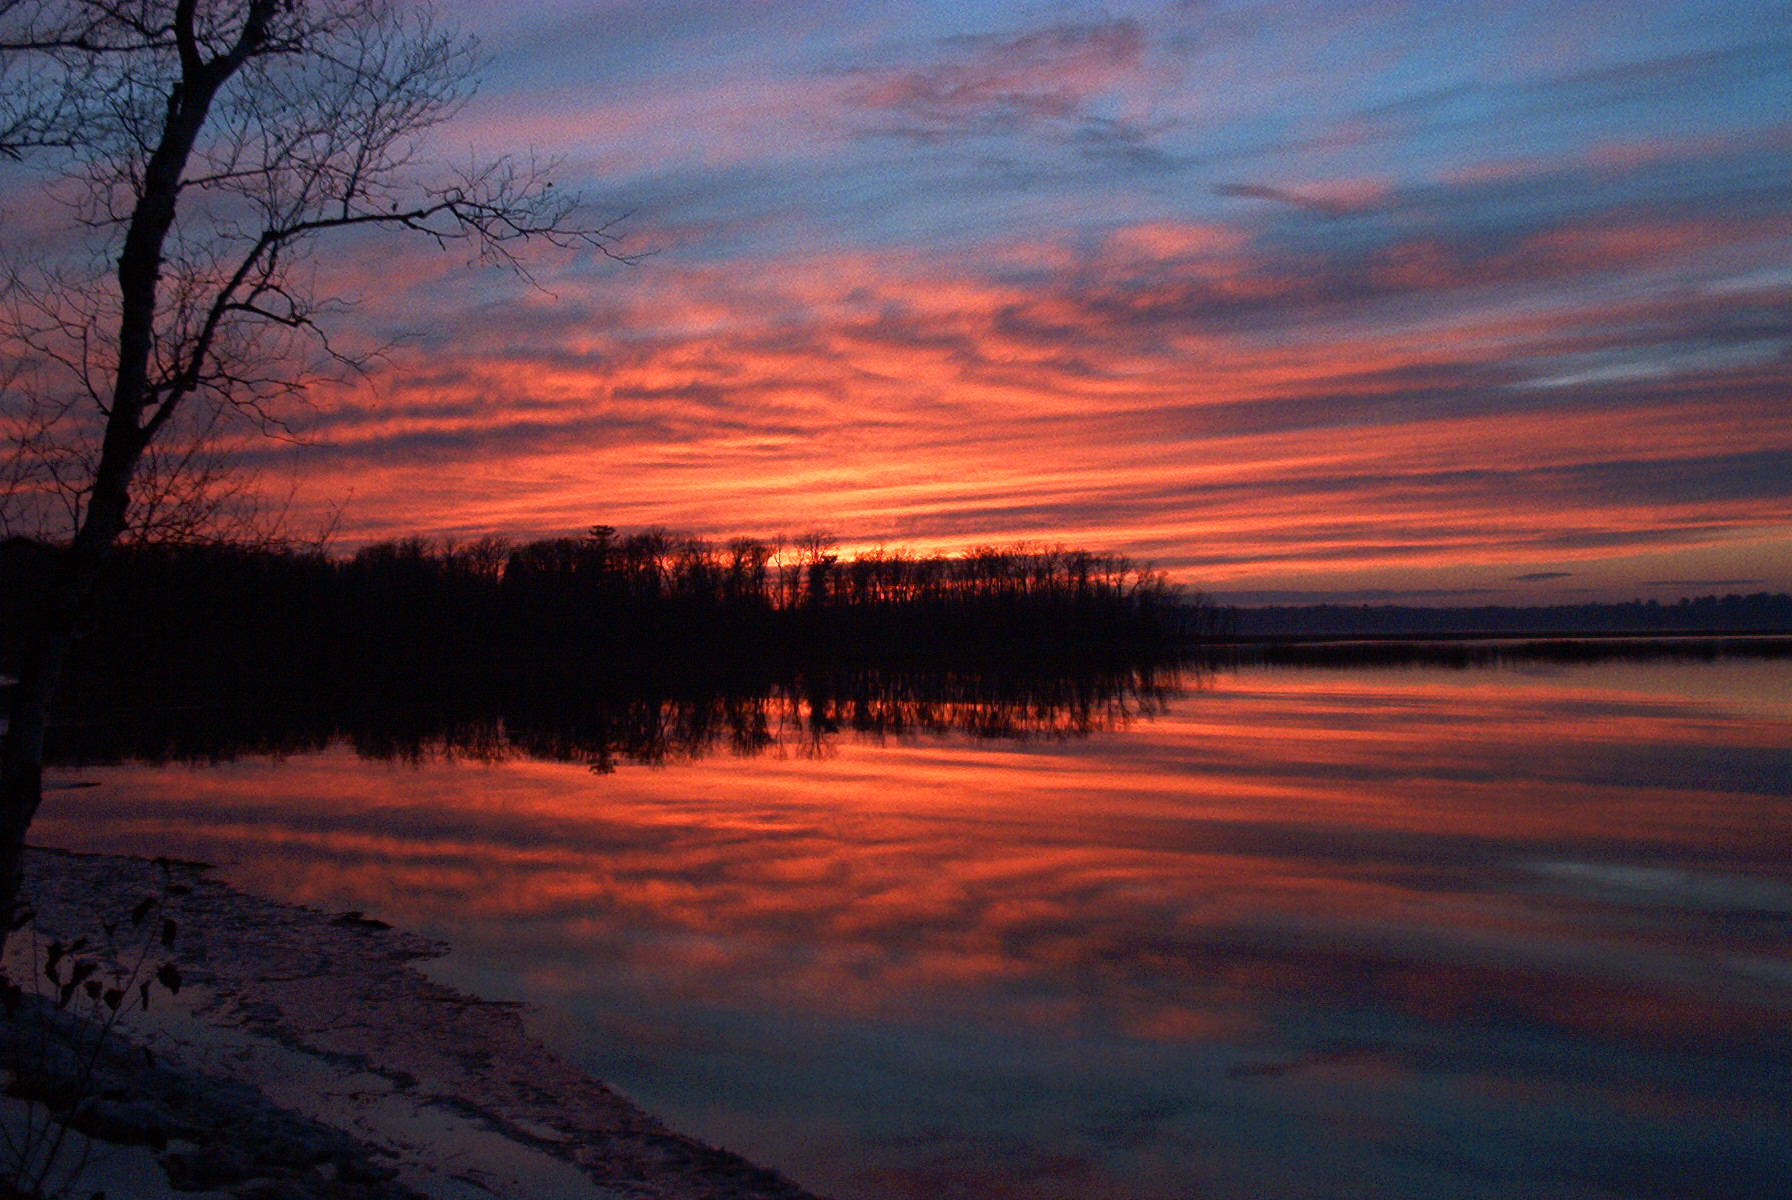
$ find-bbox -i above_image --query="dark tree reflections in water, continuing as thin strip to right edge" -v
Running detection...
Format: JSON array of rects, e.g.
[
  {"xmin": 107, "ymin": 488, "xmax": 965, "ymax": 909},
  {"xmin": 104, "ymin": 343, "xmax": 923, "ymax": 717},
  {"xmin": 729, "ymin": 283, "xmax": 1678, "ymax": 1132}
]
[{"xmin": 50, "ymin": 636, "xmax": 1792, "ymax": 772}]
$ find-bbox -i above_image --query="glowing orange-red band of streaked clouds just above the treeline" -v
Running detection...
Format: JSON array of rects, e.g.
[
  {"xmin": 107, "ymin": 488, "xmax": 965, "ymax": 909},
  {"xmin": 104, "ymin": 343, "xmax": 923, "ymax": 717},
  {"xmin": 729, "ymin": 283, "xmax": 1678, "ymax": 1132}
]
[{"xmin": 189, "ymin": 196, "xmax": 1792, "ymax": 601}]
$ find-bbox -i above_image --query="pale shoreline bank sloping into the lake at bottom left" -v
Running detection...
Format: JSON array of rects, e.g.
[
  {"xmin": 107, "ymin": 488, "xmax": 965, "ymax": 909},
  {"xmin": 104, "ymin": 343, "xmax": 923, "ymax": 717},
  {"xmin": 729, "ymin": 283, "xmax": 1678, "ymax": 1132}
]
[{"xmin": 5, "ymin": 851, "xmax": 810, "ymax": 1200}]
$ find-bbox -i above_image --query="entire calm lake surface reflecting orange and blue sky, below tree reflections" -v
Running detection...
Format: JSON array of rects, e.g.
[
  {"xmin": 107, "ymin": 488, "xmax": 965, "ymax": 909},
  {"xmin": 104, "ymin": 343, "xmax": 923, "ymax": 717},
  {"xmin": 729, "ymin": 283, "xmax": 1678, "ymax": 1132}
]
[{"xmin": 34, "ymin": 659, "xmax": 1792, "ymax": 1200}]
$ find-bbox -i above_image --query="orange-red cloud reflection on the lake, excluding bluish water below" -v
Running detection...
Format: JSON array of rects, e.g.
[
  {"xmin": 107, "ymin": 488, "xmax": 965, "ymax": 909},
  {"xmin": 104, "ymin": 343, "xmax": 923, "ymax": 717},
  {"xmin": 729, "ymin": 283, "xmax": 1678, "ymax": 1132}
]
[{"xmin": 39, "ymin": 663, "xmax": 1792, "ymax": 1037}]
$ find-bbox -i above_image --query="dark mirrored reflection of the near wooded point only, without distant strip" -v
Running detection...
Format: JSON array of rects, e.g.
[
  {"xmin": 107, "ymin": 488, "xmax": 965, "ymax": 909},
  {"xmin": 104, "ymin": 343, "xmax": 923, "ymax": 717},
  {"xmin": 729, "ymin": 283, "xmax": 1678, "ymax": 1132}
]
[{"xmin": 52, "ymin": 661, "xmax": 1206, "ymax": 772}]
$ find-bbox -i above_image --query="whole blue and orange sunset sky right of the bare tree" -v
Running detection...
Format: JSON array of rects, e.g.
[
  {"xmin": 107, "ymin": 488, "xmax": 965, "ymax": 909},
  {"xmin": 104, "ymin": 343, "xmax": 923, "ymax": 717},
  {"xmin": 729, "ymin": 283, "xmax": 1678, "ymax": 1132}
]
[{"xmin": 181, "ymin": 0, "xmax": 1792, "ymax": 604}]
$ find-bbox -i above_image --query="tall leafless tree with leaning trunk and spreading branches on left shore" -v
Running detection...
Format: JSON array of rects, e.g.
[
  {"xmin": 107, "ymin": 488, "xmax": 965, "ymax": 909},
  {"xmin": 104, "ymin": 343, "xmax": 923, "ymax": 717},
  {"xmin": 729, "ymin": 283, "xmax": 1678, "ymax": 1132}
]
[{"xmin": 0, "ymin": 0, "xmax": 615, "ymax": 937}]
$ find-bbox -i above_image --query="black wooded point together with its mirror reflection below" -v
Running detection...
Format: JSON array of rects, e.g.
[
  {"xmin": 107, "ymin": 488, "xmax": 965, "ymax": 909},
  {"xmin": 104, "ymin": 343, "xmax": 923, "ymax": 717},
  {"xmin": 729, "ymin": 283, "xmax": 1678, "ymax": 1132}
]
[{"xmin": 0, "ymin": 527, "xmax": 1211, "ymax": 770}]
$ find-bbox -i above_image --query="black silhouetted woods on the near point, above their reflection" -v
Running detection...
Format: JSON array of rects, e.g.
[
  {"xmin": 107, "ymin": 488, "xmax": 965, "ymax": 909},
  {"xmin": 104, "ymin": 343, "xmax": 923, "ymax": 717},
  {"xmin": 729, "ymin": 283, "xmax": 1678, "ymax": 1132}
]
[{"xmin": 0, "ymin": 527, "xmax": 1206, "ymax": 682}]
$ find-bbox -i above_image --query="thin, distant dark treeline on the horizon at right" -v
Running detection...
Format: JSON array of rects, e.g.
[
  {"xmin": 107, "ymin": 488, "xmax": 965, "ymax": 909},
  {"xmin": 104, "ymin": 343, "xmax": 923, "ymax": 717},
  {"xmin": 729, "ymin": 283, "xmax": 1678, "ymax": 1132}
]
[{"xmin": 1232, "ymin": 591, "xmax": 1792, "ymax": 638}]
